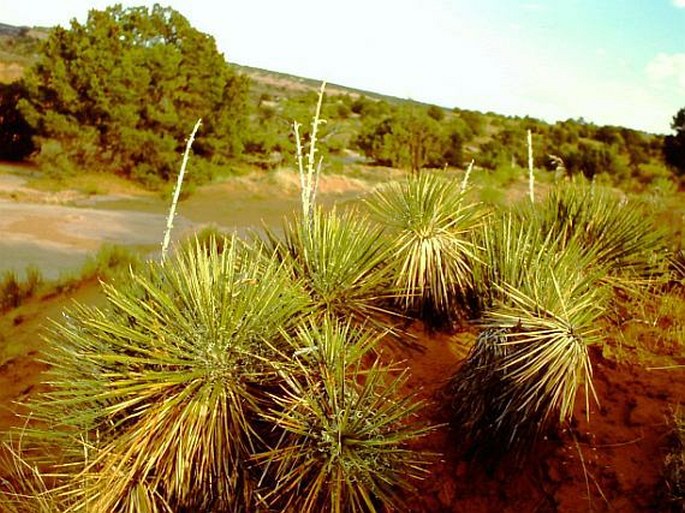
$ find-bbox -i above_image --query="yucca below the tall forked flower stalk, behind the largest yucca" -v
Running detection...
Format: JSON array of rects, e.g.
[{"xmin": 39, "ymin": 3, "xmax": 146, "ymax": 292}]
[{"xmin": 265, "ymin": 207, "xmax": 390, "ymax": 327}]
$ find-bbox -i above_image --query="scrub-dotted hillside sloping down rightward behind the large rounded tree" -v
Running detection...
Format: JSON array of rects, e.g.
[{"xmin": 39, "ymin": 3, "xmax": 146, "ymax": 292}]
[{"xmin": 0, "ymin": 21, "xmax": 678, "ymax": 192}]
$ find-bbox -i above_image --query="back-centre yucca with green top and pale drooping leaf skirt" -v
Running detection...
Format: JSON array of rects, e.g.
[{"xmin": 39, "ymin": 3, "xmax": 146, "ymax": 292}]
[{"xmin": 366, "ymin": 173, "xmax": 483, "ymax": 325}]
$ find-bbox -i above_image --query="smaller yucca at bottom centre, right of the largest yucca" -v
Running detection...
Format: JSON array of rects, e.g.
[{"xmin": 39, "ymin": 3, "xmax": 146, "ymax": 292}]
[{"xmin": 258, "ymin": 317, "xmax": 432, "ymax": 513}]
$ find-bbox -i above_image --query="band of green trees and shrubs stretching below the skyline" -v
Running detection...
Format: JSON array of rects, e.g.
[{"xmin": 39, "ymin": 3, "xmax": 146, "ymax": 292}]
[{"xmin": 0, "ymin": 17, "xmax": 684, "ymax": 191}]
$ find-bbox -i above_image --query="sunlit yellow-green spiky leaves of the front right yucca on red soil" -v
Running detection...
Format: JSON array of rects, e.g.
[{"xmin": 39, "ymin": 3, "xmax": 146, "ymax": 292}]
[{"xmin": 483, "ymin": 268, "xmax": 606, "ymax": 421}]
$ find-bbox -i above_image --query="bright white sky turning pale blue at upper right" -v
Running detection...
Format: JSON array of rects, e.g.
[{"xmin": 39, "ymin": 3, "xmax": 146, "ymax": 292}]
[{"xmin": 0, "ymin": 0, "xmax": 685, "ymax": 133}]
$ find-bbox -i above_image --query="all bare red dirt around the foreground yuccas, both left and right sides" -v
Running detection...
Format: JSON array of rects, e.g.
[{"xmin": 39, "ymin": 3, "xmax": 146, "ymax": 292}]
[{"xmin": 0, "ymin": 285, "xmax": 685, "ymax": 513}]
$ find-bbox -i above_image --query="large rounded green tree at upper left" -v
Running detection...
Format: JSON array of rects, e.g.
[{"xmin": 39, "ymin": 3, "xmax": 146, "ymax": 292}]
[{"xmin": 19, "ymin": 5, "xmax": 247, "ymax": 184}]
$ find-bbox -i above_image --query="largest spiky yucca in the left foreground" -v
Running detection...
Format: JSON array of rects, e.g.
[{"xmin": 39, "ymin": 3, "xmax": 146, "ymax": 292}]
[{"xmin": 9, "ymin": 238, "xmax": 306, "ymax": 513}]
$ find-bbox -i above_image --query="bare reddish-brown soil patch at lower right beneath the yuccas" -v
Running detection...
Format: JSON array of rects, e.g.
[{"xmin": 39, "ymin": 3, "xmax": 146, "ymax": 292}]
[{"xmin": 396, "ymin": 324, "xmax": 685, "ymax": 513}]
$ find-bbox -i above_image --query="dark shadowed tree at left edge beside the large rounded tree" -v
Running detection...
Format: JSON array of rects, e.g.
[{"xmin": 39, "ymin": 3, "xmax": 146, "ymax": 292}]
[{"xmin": 0, "ymin": 82, "xmax": 35, "ymax": 161}]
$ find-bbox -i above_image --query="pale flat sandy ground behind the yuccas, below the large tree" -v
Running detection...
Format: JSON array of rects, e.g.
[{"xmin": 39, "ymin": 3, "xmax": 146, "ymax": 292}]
[{"xmin": 0, "ymin": 170, "xmax": 368, "ymax": 279}]
